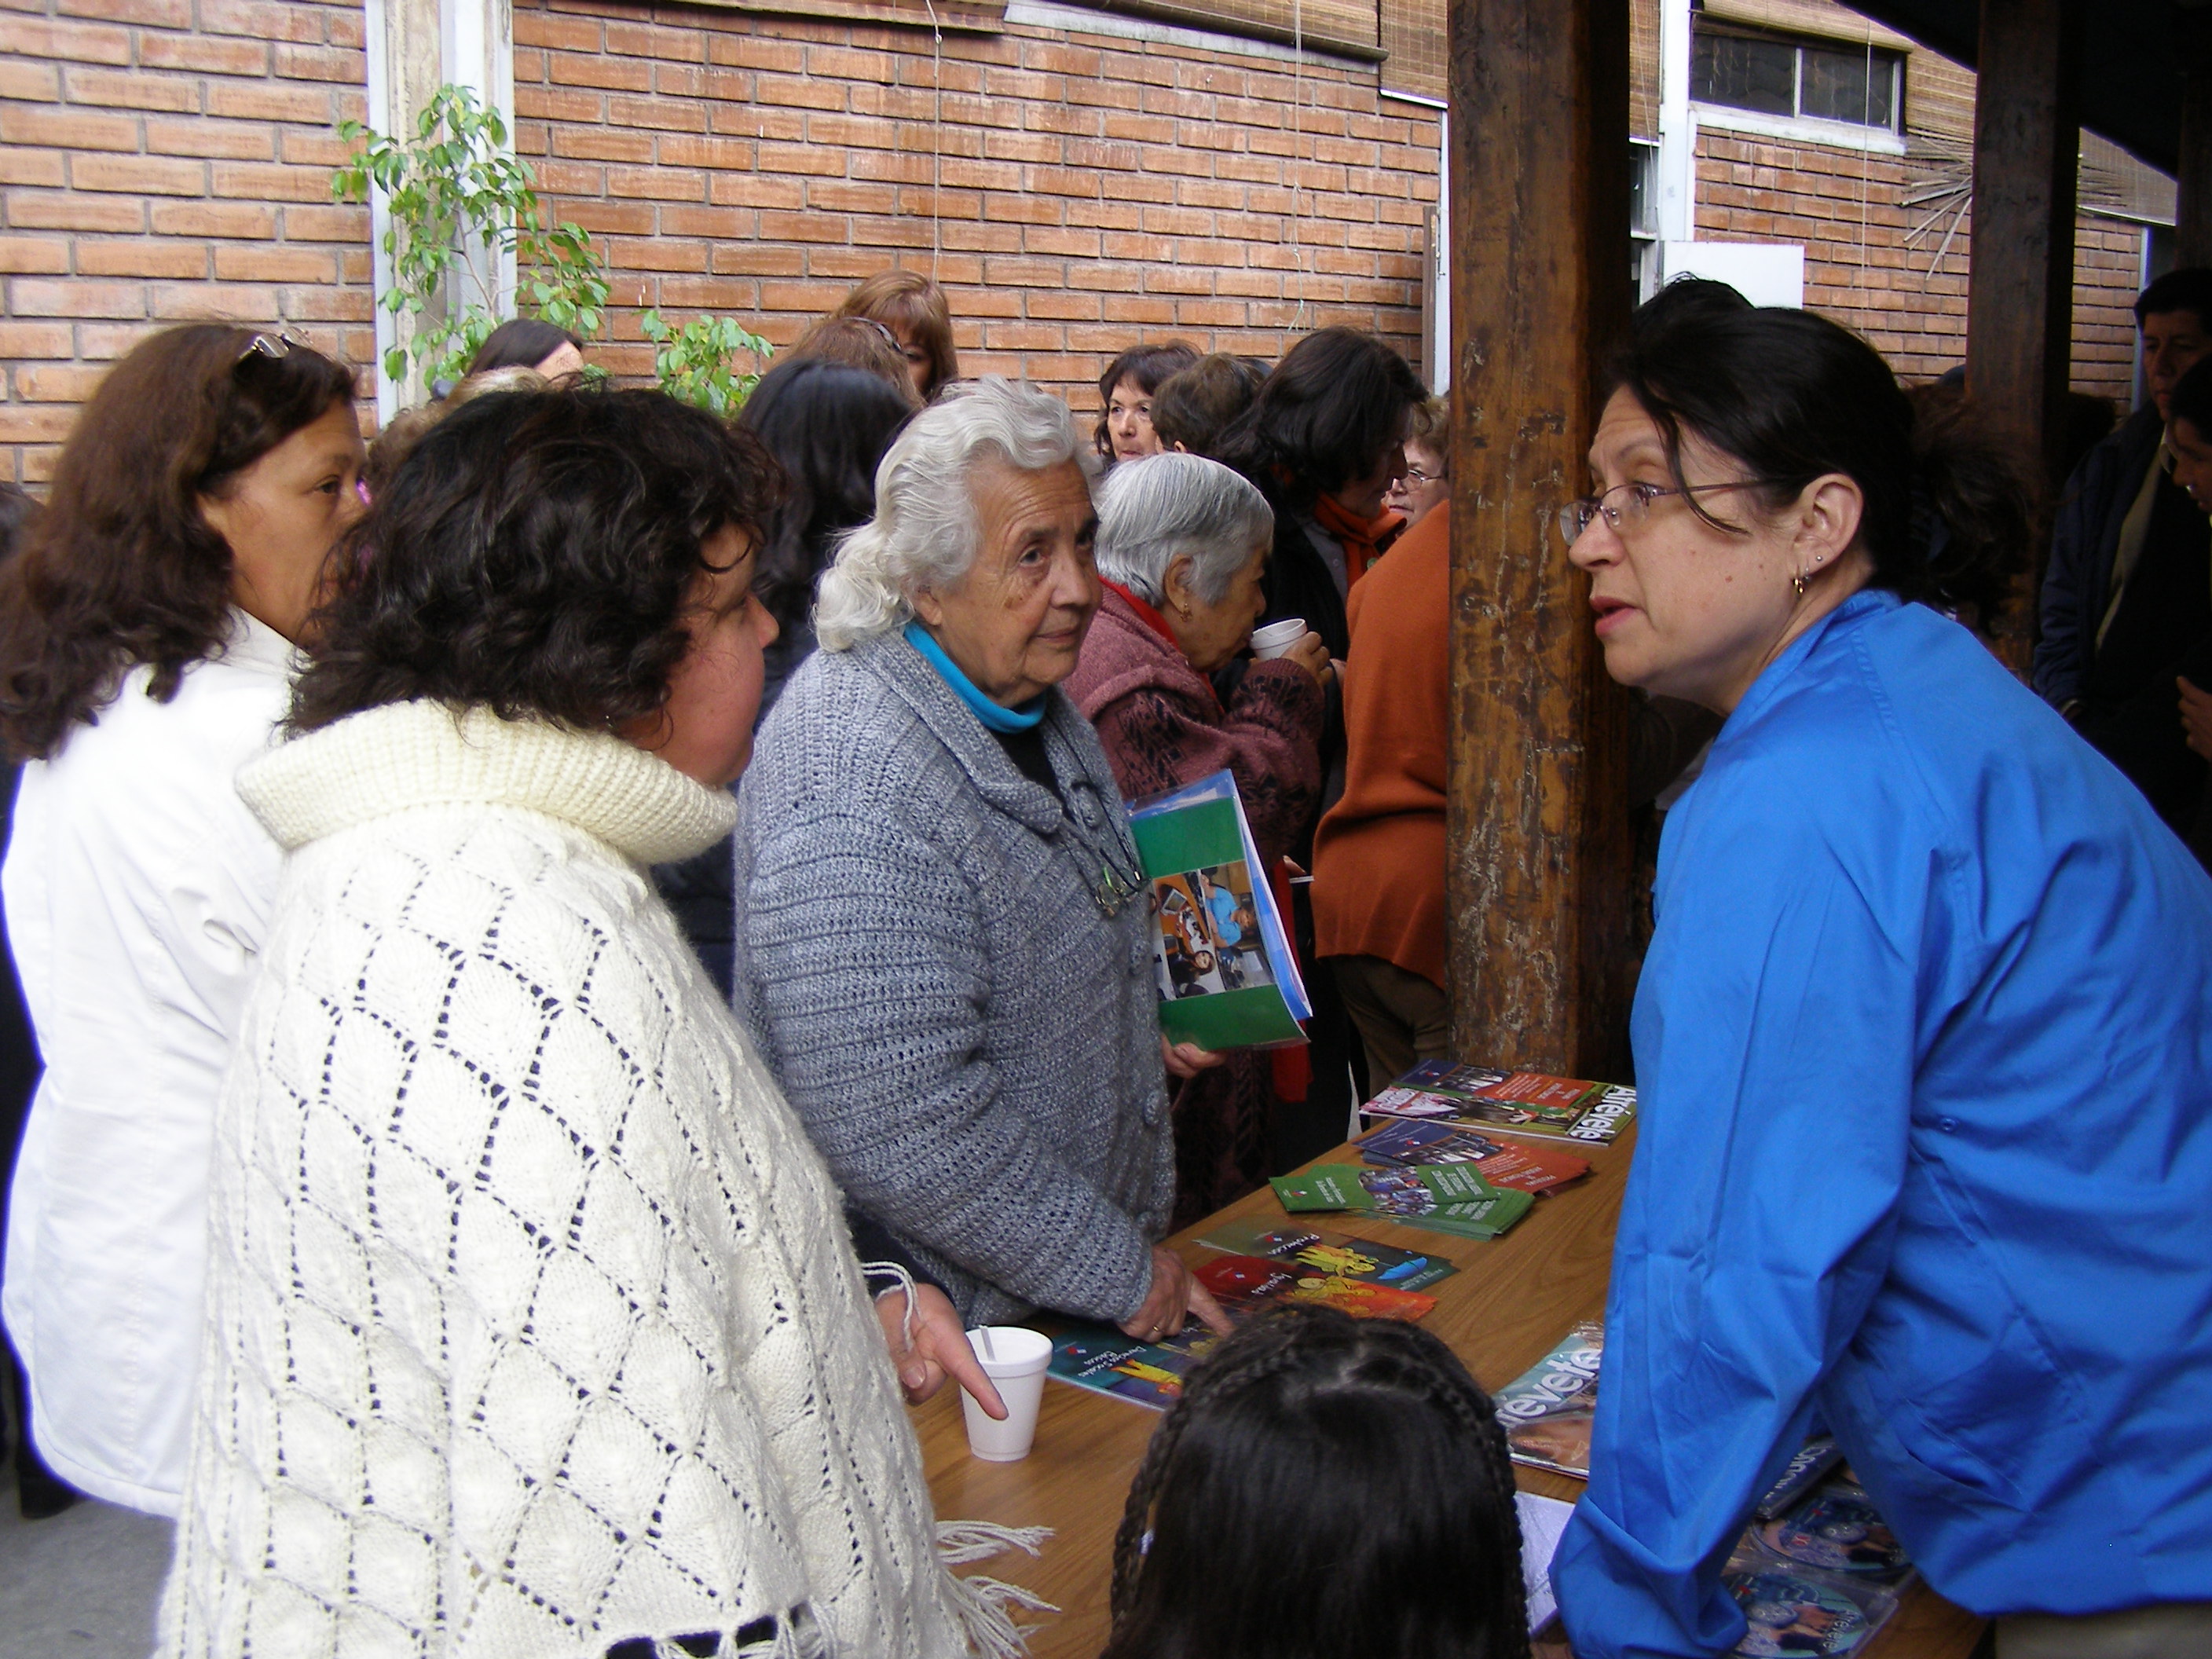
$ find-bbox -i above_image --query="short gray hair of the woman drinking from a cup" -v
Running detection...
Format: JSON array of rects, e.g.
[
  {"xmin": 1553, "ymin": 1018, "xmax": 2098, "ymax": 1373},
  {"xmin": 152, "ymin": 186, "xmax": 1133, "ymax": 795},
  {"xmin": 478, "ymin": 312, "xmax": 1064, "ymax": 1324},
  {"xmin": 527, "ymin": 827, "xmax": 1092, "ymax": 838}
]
[{"xmin": 1097, "ymin": 453, "xmax": 1274, "ymax": 604}]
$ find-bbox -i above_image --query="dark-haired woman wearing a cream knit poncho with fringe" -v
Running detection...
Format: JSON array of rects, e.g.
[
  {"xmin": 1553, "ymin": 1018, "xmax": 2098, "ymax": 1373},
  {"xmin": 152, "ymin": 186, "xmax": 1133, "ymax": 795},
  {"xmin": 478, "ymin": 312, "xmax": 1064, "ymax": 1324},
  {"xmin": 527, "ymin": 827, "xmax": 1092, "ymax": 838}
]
[{"xmin": 162, "ymin": 391, "xmax": 1027, "ymax": 1659}]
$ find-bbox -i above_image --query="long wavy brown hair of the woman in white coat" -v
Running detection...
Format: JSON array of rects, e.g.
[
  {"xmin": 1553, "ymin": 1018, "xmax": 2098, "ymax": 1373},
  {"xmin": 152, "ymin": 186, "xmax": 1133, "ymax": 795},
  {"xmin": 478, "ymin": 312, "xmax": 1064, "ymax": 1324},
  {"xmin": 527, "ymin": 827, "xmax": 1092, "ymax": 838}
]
[{"xmin": 0, "ymin": 323, "xmax": 354, "ymax": 761}]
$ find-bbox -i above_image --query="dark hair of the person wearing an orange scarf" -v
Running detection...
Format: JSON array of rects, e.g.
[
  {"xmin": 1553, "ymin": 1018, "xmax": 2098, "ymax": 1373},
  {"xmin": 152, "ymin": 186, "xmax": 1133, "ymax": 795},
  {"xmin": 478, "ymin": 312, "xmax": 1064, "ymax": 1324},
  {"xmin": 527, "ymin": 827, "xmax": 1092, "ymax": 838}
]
[{"xmin": 1217, "ymin": 328, "xmax": 1429, "ymax": 511}]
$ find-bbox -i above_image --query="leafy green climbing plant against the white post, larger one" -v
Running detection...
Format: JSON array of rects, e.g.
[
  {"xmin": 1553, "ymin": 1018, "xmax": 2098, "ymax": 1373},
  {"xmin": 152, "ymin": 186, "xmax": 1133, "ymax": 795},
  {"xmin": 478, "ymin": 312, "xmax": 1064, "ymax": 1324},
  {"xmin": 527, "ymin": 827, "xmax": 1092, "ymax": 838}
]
[{"xmin": 330, "ymin": 84, "xmax": 606, "ymax": 394}]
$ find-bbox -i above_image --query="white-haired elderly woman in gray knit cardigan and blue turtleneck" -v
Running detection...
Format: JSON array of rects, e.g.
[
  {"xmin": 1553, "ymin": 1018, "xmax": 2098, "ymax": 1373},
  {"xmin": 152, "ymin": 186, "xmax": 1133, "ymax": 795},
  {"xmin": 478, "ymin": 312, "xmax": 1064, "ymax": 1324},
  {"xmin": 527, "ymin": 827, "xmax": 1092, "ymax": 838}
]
[{"xmin": 737, "ymin": 379, "xmax": 1225, "ymax": 1339}]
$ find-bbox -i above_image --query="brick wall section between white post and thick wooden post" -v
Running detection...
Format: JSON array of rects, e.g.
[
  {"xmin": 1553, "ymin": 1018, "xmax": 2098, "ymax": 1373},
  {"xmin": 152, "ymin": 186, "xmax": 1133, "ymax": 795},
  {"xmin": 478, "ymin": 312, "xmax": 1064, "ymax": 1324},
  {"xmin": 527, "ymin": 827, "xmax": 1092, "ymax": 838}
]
[{"xmin": 515, "ymin": 0, "xmax": 1437, "ymax": 412}]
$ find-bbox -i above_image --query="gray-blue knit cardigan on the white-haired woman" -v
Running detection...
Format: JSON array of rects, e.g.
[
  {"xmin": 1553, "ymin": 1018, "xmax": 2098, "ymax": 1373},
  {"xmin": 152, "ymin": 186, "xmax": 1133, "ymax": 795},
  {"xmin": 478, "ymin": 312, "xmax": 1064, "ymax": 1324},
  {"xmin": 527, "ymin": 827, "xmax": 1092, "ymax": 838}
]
[{"xmin": 734, "ymin": 632, "xmax": 1174, "ymax": 1325}]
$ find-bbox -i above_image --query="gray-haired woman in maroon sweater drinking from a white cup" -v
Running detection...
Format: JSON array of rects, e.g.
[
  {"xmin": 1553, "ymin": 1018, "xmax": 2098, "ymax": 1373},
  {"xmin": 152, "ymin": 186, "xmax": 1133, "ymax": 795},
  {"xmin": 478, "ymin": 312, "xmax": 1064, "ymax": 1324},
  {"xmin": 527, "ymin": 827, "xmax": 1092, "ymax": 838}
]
[{"xmin": 1066, "ymin": 456, "xmax": 1329, "ymax": 1228}]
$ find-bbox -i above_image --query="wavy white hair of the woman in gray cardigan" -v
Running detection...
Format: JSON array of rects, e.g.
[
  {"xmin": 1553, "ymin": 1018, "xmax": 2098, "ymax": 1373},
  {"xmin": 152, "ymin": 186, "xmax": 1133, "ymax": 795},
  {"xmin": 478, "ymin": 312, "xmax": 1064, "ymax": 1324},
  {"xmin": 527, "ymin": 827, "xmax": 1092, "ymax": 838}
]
[{"xmin": 814, "ymin": 374, "xmax": 1100, "ymax": 650}]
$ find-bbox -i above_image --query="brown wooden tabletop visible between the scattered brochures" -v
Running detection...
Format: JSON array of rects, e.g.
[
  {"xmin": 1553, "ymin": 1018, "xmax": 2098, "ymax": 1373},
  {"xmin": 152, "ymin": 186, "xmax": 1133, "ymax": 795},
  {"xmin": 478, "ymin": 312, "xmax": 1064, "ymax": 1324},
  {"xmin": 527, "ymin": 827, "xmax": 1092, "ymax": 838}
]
[{"xmin": 914, "ymin": 1130, "xmax": 1982, "ymax": 1659}]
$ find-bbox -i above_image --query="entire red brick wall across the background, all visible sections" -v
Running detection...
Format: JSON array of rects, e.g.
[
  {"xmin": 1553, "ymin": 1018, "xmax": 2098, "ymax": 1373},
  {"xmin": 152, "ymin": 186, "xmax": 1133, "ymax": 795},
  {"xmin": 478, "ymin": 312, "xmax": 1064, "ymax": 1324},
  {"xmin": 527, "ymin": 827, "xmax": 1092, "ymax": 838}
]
[{"xmin": 0, "ymin": 0, "xmax": 2139, "ymax": 482}]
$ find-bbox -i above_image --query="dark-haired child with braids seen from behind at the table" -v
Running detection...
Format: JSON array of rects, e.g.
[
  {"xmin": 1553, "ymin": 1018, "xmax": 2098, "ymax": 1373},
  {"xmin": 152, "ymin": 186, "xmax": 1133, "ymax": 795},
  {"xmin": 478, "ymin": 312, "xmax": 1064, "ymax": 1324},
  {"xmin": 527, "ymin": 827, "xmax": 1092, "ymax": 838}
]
[{"xmin": 1101, "ymin": 1305, "xmax": 1529, "ymax": 1659}]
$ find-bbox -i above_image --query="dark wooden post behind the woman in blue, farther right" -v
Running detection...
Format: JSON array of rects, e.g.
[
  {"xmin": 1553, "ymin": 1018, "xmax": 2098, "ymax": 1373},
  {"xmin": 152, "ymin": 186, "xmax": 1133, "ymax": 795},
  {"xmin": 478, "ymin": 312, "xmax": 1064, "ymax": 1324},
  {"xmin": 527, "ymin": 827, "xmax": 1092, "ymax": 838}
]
[{"xmin": 1966, "ymin": 0, "xmax": 2082, "ymax": 670}]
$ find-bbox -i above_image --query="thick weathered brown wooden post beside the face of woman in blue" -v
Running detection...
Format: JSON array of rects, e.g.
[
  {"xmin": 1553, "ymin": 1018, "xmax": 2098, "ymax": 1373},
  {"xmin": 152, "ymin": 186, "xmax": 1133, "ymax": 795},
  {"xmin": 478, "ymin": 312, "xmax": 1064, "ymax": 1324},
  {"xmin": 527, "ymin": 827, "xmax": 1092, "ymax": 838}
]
[{"xmin": 1445, "ymin": 0, "xmax": 1637, "ymax": 1079}]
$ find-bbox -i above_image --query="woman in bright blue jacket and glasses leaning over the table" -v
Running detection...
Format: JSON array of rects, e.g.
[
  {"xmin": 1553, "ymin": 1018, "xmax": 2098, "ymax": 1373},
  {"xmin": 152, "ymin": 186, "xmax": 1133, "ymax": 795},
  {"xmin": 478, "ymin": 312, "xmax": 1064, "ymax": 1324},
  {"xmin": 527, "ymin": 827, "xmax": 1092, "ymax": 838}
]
[{"xmin": 1553, "ymin": 283, "xmax": 2212, "ymax": 1659}]
